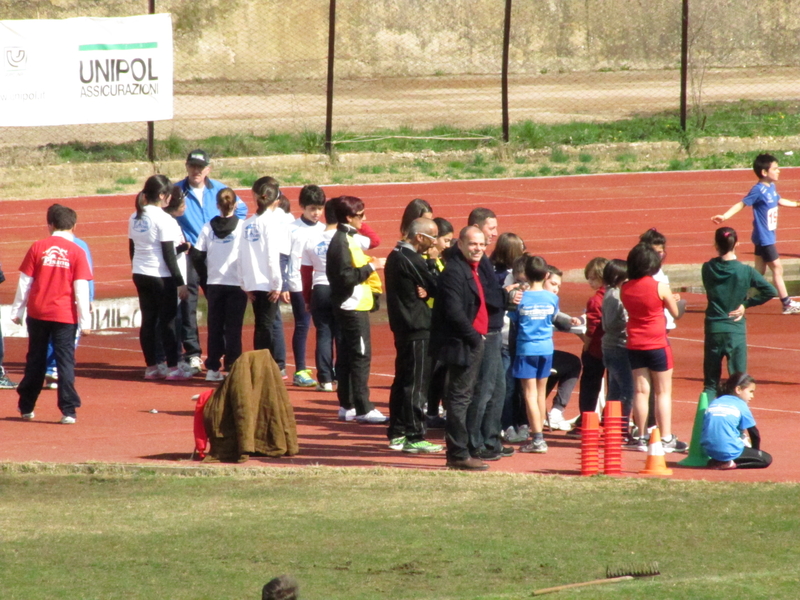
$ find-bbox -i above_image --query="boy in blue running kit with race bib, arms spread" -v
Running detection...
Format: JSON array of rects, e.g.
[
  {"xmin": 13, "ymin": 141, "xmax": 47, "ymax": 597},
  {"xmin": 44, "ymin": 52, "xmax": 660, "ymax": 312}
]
[{"xmin": 711, "ymin": 154, "xmax": 800, "ymax": 315}]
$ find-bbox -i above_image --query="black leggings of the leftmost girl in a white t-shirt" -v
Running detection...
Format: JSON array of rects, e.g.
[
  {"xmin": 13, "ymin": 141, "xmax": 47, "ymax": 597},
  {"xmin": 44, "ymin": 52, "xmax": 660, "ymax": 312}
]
[{"xmin": 133, "ymin": 273, "xmax": 180, "ymax": 367}]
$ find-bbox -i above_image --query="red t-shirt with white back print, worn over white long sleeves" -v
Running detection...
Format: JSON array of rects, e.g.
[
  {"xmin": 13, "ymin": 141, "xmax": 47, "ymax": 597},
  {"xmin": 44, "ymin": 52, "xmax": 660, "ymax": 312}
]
[{"xmin": 19, "ymin": 235, "xmax": 93, "ymax": 323}]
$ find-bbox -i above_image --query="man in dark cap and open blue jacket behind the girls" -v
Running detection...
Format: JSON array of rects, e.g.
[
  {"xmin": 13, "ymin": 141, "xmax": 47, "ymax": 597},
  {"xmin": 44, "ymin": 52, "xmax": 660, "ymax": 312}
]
[{"xmin": 176, "ymin": 149, "xmax": 247, "ymax": 373}]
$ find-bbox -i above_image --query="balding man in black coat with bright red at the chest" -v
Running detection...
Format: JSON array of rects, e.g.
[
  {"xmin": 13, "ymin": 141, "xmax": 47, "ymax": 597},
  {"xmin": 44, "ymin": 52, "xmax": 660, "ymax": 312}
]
[{"xmin": 432, "ymin": 227, "xmax": 489, "ymax": 471}]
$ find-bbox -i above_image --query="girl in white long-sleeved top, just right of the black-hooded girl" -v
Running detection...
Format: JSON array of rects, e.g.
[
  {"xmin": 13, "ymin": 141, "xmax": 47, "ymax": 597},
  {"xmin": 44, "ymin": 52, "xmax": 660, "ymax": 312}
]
[{"xmin": 239, "ymin": 177, "xmax": 291, "ymax": 362}]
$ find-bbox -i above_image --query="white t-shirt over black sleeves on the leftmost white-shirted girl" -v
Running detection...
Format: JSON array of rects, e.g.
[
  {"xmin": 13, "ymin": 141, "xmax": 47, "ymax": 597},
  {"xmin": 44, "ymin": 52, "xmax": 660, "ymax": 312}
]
[{"xmin": 128, "ymin": 204, "xmax": 180, "ymax": 277}]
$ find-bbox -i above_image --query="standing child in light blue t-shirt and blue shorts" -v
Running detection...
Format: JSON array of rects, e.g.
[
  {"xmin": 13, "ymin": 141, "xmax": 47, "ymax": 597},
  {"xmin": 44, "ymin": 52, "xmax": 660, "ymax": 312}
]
[{"xmin": 508, "ymin": 256, "xmax": 558, "ymax": 454}]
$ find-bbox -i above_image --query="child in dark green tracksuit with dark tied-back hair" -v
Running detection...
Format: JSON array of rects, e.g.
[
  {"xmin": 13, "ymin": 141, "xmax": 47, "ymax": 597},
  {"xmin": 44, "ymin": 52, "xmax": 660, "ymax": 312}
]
[{"xmin": 701, "ymin": 227, "xmax": 777, "ymax": 401}]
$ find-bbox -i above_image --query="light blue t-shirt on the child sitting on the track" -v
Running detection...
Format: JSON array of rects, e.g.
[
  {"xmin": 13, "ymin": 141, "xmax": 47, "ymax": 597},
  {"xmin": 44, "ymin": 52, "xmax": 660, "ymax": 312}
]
[{"xmin": 700, "ymin": 396, "xmax": 756, "ymax": 461}]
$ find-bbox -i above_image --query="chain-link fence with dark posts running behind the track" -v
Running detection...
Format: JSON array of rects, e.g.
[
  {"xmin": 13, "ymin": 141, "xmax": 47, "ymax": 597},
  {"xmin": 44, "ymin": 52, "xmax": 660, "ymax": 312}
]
[{"xmin": 0, "ymin": 0, "xmax": 800, "ymax": 162}]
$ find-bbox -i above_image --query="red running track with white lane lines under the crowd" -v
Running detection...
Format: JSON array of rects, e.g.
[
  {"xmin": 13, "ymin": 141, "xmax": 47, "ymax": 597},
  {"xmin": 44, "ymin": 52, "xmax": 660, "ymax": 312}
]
[{"xmin": 0, "ymin": 169, "xmax": 800, "ymax": 481}]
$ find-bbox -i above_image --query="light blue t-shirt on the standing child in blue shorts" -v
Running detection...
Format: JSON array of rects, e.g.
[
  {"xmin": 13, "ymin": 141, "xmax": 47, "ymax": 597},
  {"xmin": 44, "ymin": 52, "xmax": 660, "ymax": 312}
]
[{"xmin": 508, "ymin": 290, "xmax": 558, "ymax": 356}]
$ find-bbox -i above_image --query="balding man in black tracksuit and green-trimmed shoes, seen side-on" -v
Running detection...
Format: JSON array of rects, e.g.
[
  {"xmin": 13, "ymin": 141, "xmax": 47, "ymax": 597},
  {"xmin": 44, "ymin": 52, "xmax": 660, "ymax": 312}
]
[{"xmin": 384, "ymin": 217, "xmax": 442, "ymax": 454}]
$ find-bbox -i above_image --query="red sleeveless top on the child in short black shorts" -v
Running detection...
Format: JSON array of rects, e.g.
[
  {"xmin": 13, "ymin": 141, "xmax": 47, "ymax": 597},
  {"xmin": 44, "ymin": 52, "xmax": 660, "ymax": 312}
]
[{"xmin": 620, "ymin": 277, "xmax": 669, "ymax": 350}]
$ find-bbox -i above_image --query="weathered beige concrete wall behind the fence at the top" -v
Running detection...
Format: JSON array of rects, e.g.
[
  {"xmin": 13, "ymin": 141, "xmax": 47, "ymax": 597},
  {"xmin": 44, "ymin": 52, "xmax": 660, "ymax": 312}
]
[{"xmin": 6, "ymin": 0, "xmax": 800, "ymax": 81}]
